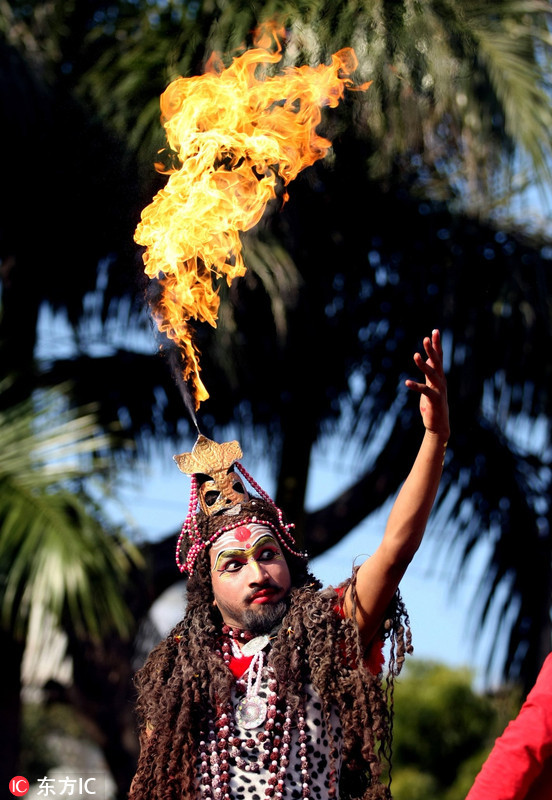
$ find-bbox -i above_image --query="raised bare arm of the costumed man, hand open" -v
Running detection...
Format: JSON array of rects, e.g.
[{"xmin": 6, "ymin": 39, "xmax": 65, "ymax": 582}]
[{"xmin": 344, "ymin": 330, "xmax": 450, "ymax": 644}]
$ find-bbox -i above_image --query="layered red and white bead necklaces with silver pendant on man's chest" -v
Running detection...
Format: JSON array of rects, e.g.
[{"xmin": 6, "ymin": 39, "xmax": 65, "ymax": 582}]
[{"xmin": 199, "ymin": 626, "xmax": 310, "ymax": 800}]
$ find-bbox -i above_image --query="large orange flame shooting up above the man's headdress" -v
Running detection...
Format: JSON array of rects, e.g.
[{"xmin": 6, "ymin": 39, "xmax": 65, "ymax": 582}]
[{"xmin": 135, "ymin": 30, "xmax": 364, "ymax": 410}]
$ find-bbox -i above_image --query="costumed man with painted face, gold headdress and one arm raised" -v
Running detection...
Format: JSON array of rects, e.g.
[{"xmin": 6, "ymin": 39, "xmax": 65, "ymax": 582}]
[{"xmin": 130, "ymin": 331, "xmax": 449, "ymax": 800}]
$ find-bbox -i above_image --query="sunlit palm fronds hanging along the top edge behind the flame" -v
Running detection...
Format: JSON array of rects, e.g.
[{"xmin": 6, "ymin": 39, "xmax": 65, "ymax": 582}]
[{"xmin": 79, "ymin": 0, "xmax": 551, "ymax": 200}]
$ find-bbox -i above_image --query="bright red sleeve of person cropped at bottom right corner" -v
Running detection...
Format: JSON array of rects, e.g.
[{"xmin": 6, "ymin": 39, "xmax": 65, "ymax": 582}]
[{"xmin": 466, "ymin": 653, "xmax": 552, "ymax": 800}]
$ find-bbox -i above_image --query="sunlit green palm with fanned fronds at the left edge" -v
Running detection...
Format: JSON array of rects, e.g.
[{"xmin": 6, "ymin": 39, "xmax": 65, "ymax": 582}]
[{"xmin": 0, "ymin": 384, "xmax": 140, "ymax": 781}]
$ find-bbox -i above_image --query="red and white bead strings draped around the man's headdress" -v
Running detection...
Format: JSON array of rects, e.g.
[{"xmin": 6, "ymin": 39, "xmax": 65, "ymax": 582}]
[{"xmin": 176, "ymin": 461, "xmax": 307, "ymax": 575}]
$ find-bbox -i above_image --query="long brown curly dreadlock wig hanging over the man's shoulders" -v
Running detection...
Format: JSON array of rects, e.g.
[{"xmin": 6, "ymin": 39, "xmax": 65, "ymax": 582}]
[{"xmin": 129, "ymin": 498, "xmax": 412, "ymax": 800}]
